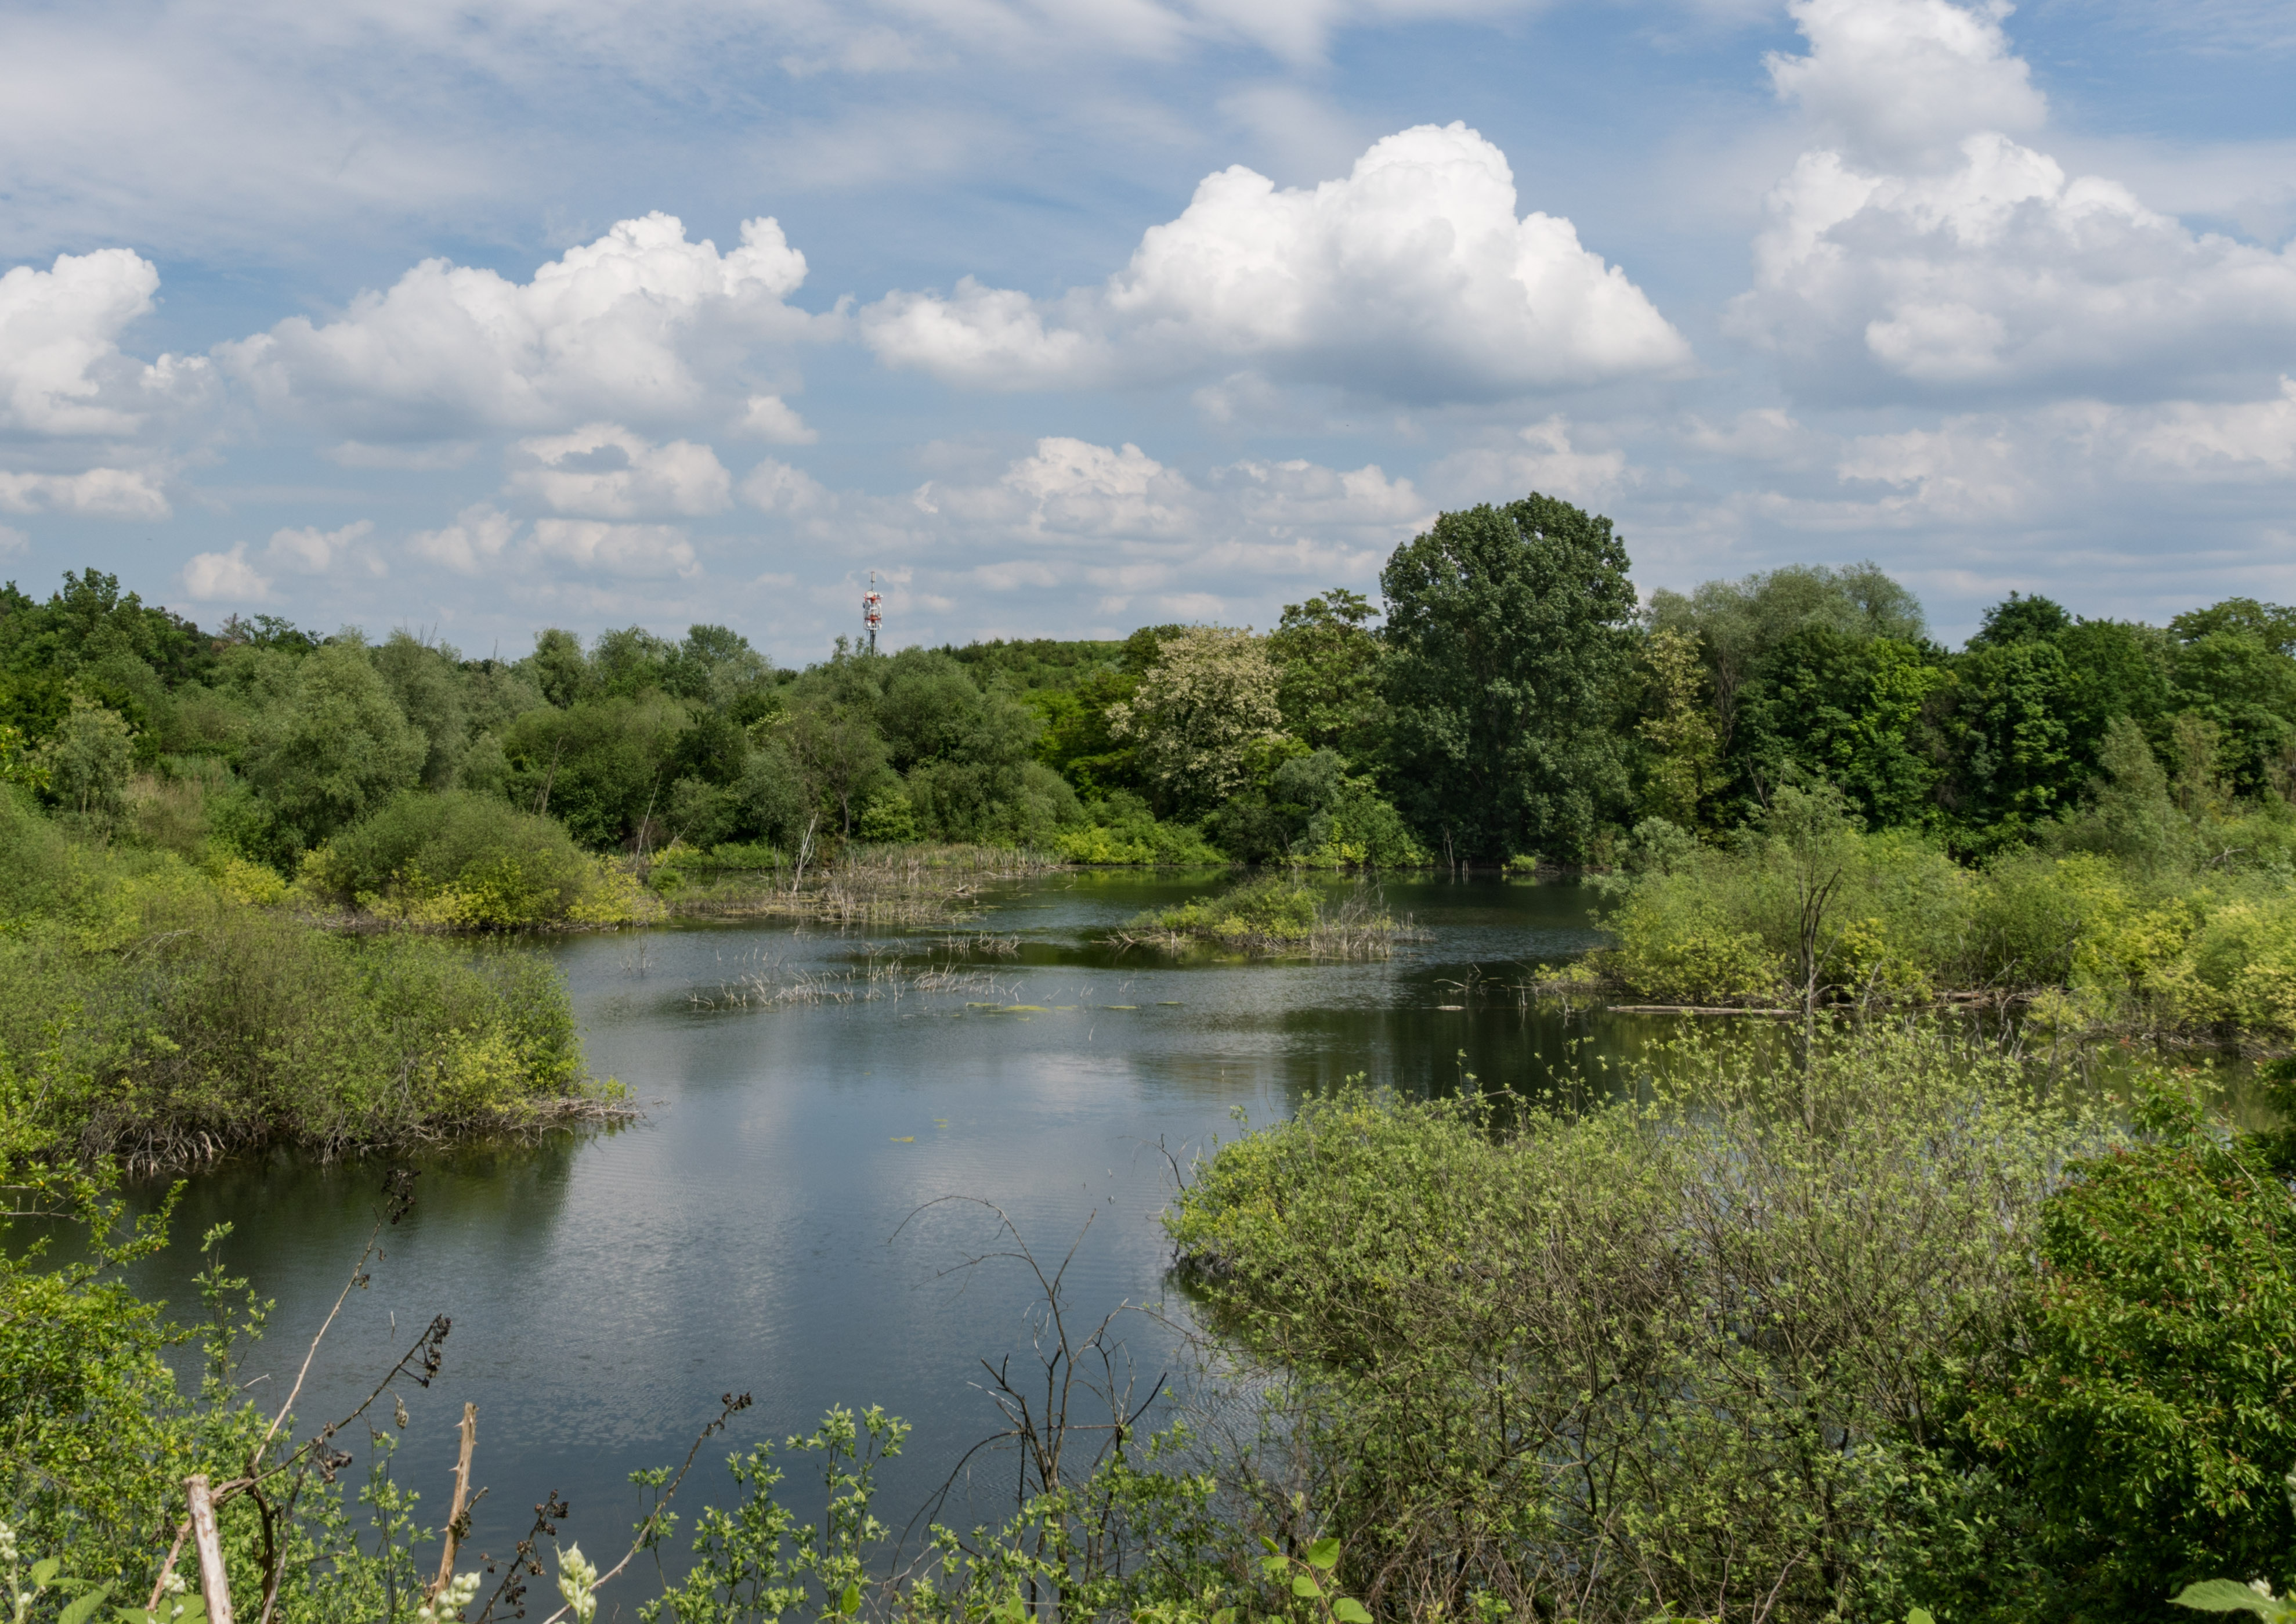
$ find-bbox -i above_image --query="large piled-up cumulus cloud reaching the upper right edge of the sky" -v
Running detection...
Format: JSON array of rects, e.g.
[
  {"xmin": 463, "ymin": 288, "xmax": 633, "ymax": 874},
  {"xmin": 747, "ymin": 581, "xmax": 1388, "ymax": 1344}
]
[{"xmin": 1729, "ymin": 0, "xmax": 2296, "ymax": 400}]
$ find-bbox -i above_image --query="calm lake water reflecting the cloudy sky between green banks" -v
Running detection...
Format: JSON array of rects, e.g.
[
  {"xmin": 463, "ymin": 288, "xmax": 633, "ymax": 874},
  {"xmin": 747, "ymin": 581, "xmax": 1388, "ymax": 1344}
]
[{"xmin": 116, "ymin": 873, "xmax": 1630, "ymax": 1553}]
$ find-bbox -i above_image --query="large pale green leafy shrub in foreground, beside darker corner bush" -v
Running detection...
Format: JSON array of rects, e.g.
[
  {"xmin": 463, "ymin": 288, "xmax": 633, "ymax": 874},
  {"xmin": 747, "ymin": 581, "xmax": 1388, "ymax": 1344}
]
[{"xmin": 1166, "ymin": 1029, "xmax": 2099, "ymax": 1624}]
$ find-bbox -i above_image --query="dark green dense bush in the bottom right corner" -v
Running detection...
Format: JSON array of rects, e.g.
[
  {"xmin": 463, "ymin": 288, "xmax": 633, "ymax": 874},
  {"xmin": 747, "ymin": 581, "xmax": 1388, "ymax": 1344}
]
[{"xmin": 1954, "ymin": 1091, "xmax": 2296, "ymax": 1624}]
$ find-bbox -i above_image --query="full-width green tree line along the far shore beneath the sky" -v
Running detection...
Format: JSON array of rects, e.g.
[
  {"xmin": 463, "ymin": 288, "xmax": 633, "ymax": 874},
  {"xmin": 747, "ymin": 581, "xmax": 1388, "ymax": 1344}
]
[{"xmin": 0, "ymin": 494, "xmax": 2296, "ymax": 891}]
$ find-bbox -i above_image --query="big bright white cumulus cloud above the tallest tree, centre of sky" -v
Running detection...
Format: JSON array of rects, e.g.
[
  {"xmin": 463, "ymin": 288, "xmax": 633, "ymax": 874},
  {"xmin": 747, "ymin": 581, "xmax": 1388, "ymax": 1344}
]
[{"xmin": 861, "ymin": 124, "xmax": 1690, "ymax": 400}]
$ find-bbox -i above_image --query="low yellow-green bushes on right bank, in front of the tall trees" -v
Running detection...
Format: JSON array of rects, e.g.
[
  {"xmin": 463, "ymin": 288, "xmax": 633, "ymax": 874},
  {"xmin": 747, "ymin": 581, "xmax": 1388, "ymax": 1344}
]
[{"xmin": 1593, "ymin": 762, "xmax": 2296, "ymax": 1041}]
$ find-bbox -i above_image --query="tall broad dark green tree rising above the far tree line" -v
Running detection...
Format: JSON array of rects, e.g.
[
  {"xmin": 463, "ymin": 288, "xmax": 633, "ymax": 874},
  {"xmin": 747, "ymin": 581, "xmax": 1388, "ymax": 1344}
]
[{"xmin": 1380, "ymin": 494, "xmax": 1635, "ymax": 861}]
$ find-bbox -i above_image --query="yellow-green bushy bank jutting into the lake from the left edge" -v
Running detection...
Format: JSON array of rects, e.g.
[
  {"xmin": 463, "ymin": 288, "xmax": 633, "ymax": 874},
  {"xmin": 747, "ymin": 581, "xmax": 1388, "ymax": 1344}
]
[{"xmin": 0, "ymin": 792, "xmax": 611, "ymax": 1167}]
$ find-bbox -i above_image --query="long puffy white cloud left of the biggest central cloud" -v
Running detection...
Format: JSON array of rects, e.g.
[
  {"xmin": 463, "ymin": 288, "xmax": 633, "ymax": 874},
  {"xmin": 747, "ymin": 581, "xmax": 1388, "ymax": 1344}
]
[{"xmin": 216, "ymin": 214, "xmax": 815, "ymax": 441}]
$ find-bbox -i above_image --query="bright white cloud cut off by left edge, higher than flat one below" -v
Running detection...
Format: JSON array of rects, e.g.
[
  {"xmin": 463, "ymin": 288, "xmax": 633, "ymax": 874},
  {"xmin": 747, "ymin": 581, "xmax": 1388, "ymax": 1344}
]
[{"xmin": 0, "ymin": 248, "xmax": 211, "ymax": 439}]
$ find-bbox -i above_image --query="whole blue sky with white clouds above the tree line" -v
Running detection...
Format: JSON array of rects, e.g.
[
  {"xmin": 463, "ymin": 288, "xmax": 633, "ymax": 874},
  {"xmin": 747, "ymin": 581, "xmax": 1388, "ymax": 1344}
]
[{"xmin": 0, "ymin": 0, "xmax": 2296, "ymax": 662}]
